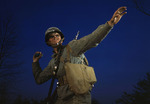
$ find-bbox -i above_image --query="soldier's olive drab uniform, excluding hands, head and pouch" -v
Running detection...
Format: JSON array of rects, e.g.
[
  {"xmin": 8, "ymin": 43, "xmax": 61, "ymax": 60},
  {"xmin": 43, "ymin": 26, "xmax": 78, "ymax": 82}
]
[{"xmin": 32, "ymin": 23, "xmax": 112, "ymax": 104}]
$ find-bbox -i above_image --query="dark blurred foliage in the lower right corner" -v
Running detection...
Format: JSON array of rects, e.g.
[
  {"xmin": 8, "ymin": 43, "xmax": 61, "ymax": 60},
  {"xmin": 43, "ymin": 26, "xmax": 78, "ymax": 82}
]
[{"xmin": 116, "ymin": 73, "xmax": 150, "ymax": 104}]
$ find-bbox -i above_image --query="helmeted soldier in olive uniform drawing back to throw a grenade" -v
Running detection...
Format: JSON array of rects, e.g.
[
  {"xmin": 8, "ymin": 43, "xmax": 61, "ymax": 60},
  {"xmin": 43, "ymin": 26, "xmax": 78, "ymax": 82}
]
[{"xmin": 32, "ymin": 7, "xmax": 127, "ymax": 104}]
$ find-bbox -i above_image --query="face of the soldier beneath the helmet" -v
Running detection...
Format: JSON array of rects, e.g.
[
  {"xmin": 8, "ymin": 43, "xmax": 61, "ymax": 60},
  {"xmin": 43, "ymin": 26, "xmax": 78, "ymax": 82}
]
[{"xmin": 48, "ymin": 33, "xmax": 61, "ymax": 45}]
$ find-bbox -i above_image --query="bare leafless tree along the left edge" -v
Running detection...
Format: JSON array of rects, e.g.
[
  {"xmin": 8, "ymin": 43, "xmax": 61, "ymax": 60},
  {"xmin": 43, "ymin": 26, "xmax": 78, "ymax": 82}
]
[{"xmin": 0, "ymin": 16, "xmax": 23, "ymax": 104}]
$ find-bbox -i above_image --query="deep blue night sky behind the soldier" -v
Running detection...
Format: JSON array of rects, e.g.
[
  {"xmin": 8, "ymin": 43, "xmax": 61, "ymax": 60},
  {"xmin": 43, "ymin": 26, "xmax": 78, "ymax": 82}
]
[{"xmin": 0, "ymin": 0, "xmax": 150, "ymax": 104}]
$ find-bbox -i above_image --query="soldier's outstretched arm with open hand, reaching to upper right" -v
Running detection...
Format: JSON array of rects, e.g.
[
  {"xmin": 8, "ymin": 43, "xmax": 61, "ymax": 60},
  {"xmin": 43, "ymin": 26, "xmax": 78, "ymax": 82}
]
[{"xmin": 69, "ymin": 7, "xmax": 127, "ymax": 55}]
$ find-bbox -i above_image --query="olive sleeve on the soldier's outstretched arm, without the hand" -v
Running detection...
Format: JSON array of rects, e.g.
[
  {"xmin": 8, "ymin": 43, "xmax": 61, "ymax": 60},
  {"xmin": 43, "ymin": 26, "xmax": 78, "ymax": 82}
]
[{"xmin": 69, "ymin": 23, "xmax": 112, "ymax": 56}]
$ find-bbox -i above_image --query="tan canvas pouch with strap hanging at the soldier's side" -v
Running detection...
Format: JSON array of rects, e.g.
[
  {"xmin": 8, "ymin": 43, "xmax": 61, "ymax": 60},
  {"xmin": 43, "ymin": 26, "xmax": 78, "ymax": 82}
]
[{"xmin": 61, "ymin": 45, "xmax": 97, "ymax": 94}]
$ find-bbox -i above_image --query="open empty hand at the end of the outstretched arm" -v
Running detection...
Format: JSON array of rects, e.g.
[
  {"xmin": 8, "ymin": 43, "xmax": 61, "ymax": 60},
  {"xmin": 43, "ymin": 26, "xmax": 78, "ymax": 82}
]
[{"xmin": 108, "ymin": 7, "xmax": 127, "ymax": 26}]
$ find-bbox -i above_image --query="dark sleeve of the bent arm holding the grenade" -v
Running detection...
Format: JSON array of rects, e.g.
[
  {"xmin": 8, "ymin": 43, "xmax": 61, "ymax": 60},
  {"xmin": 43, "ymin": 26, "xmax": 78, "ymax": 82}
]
[{"xmin": 32, "ymin": 62, "xmax": 52, "ymax": 84}]
